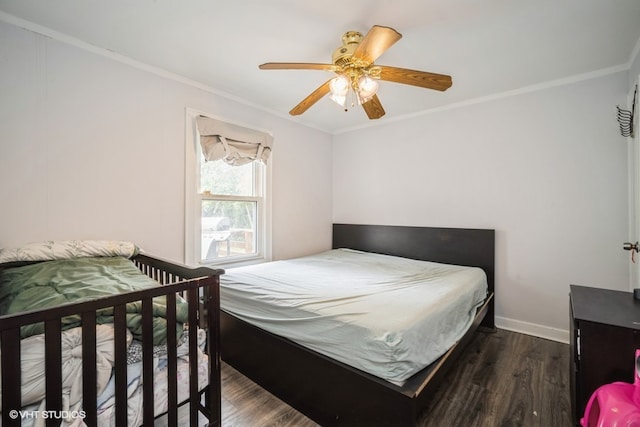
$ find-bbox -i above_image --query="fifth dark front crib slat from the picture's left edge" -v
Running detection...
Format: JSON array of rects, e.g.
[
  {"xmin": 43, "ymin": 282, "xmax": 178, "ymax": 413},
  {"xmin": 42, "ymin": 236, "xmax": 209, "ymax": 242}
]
[{"xmin": 142, "ymin": 298, "xmax": 155, "ymax": 426}]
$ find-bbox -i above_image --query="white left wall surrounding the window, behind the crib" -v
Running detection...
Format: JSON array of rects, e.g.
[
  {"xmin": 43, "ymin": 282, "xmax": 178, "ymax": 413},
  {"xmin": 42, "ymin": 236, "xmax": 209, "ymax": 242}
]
[{"xmin": 0, "ymin": 22, "xmax": 332, "ymax": 261}]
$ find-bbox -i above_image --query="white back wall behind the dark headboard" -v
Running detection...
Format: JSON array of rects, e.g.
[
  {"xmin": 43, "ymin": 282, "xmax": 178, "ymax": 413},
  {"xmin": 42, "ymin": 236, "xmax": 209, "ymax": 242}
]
[{"xmin": 333, "ymin": 73, "xmax": 629, "ymax": 341}]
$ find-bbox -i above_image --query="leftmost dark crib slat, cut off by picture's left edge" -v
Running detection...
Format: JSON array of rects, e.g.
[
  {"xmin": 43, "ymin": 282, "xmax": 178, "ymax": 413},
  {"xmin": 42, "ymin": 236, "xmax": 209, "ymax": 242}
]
[{"xmin": 0, "ymin": 328, "xmax": 22, "ymax": 427}]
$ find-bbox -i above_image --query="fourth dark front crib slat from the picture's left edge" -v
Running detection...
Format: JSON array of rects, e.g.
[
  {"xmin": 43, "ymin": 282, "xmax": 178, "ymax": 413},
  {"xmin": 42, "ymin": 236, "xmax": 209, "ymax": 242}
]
[{"xmin": 113, "ymin": 304, "xmax": 128, "ymax": 426}]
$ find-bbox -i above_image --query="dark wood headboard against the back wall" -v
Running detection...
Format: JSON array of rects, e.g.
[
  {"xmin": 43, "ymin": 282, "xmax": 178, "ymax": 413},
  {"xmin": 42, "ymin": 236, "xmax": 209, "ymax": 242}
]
[{"xmin": 333, "ymin": 224, "xmax": 495, "ymax": 293}]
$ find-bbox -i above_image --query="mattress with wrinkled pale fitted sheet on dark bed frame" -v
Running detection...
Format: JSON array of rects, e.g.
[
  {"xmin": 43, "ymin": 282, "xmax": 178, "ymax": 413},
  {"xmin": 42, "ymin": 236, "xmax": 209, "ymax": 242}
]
[{"xmin": 220, "ymin": 249, "xmax": 487, "ymax": 384}]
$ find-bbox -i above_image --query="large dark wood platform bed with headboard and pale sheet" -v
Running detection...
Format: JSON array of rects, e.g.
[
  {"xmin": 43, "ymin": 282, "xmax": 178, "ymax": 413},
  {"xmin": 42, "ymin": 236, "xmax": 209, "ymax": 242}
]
[{"xmin": 221, "ymin": 224, "xmax": 495, "ymax": 426}]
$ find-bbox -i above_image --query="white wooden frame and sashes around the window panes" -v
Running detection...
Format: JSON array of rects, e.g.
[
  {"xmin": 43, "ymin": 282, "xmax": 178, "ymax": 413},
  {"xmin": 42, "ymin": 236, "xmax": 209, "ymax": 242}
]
[{"xmin": 185, "ymin": 108, "xmax": 273, "ymax": 268}]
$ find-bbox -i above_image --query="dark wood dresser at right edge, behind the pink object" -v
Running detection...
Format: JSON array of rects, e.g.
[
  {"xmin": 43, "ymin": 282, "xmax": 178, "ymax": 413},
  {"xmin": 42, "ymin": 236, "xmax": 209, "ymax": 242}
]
[{"xmin": 570, "ymin": 285, "xmax": 640, "ymax": 425}]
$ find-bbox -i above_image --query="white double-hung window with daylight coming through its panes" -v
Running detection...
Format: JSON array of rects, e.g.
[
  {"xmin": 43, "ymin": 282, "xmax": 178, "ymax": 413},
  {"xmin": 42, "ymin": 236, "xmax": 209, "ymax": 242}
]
[{"xmin": 185, "ymin": 110, "xmax": 270, "ymax": 265}]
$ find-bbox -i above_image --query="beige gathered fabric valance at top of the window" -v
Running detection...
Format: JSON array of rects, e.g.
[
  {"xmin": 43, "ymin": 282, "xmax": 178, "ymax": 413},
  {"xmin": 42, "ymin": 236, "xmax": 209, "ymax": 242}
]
[{"xmin": 196, "ymin": 116, "xmax": 273, "ymax": 166}]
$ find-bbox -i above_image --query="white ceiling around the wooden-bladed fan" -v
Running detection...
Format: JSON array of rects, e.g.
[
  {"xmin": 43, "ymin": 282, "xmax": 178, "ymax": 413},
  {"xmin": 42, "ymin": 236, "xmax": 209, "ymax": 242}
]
[{"xmin": 0, "ymin": 0, "xmax": 640, "ymax": 133}]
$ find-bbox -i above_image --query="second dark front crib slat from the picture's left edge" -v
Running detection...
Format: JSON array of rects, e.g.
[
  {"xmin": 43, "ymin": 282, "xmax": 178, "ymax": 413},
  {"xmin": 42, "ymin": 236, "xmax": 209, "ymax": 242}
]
[{"xmin": 44, "ymin": 319, "xmax": 62, "ymax": 427}]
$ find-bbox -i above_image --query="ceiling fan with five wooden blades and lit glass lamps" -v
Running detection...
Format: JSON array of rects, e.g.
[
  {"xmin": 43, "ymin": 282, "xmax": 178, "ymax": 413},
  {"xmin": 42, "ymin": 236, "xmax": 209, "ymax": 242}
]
[{"xmin": 258, "ymin": 25, "xmax": 451, "ymax": 119}]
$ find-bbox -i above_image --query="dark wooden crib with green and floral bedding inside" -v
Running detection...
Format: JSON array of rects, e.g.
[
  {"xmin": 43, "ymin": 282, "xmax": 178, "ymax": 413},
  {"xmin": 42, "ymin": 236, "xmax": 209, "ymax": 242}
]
[{"xmin": 0, "ymin": 241, "xmax": 223, "ymax": 426}]
